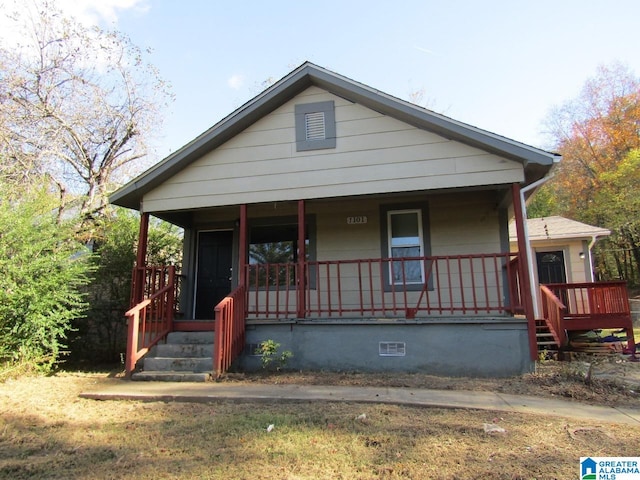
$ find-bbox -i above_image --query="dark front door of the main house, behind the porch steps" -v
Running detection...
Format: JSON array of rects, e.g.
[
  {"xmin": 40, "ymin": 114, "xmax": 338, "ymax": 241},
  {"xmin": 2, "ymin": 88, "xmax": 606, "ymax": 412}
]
[{"xmin": 195, "ymin": 231, "xmax": 233, "ymax": 320}]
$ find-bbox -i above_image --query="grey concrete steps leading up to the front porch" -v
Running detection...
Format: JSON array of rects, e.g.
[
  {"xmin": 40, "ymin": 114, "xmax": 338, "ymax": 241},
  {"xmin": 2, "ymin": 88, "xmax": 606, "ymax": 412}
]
[{"xmin": 131, "ymin": 332, "xmax": 213, "ymax": 382}]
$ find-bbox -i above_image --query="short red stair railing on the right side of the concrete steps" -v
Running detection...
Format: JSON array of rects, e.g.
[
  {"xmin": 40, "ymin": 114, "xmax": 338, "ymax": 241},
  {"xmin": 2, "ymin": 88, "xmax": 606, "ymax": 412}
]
[{"xmin": 213, "ymin": 285, "xmax": 246, "ymax": 378}]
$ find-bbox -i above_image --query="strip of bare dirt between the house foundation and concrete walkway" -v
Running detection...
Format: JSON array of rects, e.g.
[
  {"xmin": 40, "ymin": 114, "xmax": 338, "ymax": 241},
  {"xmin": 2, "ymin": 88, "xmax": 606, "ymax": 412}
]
[{"xmin": 220, "ymin": 355, "xmax": 640, "ymax": 408}]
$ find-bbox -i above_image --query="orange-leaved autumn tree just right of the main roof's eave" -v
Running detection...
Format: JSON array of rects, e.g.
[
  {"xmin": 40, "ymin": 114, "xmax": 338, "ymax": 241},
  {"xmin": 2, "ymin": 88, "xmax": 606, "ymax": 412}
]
[{"xmin": 547, "ymin": 64, "xmax": 640, "ymax": 221}]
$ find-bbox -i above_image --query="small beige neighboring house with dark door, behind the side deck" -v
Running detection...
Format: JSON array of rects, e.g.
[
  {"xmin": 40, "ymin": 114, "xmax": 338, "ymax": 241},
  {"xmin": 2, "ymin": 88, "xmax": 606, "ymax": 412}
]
[{"xmin": 509, "ymin": 216, "xmax": 611, "ymax": 284}]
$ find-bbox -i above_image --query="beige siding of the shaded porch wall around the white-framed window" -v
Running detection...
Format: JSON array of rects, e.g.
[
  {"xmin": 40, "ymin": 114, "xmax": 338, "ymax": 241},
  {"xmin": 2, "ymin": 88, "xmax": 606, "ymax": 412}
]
[{"xmin": 238, "ymin": 191, "xmax": 503, "ymax": 316}]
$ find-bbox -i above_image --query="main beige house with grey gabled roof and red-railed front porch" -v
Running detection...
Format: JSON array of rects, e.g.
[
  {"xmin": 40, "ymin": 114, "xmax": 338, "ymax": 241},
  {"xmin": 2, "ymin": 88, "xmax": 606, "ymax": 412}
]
[{"xmin": 111, "ymin": 63, "xmax": 560, "ymax": 376}]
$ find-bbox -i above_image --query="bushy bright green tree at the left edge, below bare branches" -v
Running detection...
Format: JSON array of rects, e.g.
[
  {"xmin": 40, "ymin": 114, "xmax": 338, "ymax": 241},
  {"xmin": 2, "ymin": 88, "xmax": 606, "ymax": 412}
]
[{"xmin": 0, "ymin": 183, "xmax": 91, "ymax": 375}]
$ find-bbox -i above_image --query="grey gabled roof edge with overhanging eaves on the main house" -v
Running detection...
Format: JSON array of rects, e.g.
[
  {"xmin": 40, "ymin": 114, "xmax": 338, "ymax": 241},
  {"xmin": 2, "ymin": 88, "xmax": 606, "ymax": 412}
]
[{"xmin": 110, "ymin": 62, "xmax": 560, "ymax": 209}]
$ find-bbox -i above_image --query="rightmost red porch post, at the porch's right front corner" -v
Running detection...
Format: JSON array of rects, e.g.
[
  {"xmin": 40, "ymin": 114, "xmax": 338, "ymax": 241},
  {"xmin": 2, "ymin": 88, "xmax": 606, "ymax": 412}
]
[{"xmin": 511, "ymin": 183, "xmax": 538, "ymax": 360}]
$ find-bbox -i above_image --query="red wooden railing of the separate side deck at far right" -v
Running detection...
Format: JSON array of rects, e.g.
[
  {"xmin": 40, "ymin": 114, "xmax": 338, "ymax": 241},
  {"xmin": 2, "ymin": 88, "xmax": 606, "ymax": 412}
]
[{"xmin": 541, "ymin": 282, "xmax": 635, "ymax": 353}]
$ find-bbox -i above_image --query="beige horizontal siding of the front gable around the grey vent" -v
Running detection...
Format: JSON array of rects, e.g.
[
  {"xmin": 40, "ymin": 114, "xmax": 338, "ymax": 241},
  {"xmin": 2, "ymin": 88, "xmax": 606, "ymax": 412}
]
[{"xmin": 144, "ymin": 87, "xmax": 523, "ymax": 212}]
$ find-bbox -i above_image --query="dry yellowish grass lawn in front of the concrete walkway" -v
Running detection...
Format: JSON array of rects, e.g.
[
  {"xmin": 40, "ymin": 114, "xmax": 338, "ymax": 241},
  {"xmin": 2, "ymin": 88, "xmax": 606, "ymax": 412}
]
[{"xmin": 0, "ymin": 366, "xmax": 640, "ymax": 479}]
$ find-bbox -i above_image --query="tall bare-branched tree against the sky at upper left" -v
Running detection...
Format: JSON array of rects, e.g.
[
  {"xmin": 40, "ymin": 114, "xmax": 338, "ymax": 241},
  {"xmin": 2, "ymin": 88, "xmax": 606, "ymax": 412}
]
[{"xmin": 0, "ymin": 0, "xmax": 170, "ymax": 227}]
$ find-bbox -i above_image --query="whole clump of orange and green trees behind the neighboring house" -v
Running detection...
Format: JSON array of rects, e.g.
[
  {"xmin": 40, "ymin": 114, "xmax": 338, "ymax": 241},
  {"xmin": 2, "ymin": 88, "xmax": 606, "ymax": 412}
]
[{"xmin": 532, "ymin": 63, "xmax": 640, "ymax": 284}]
